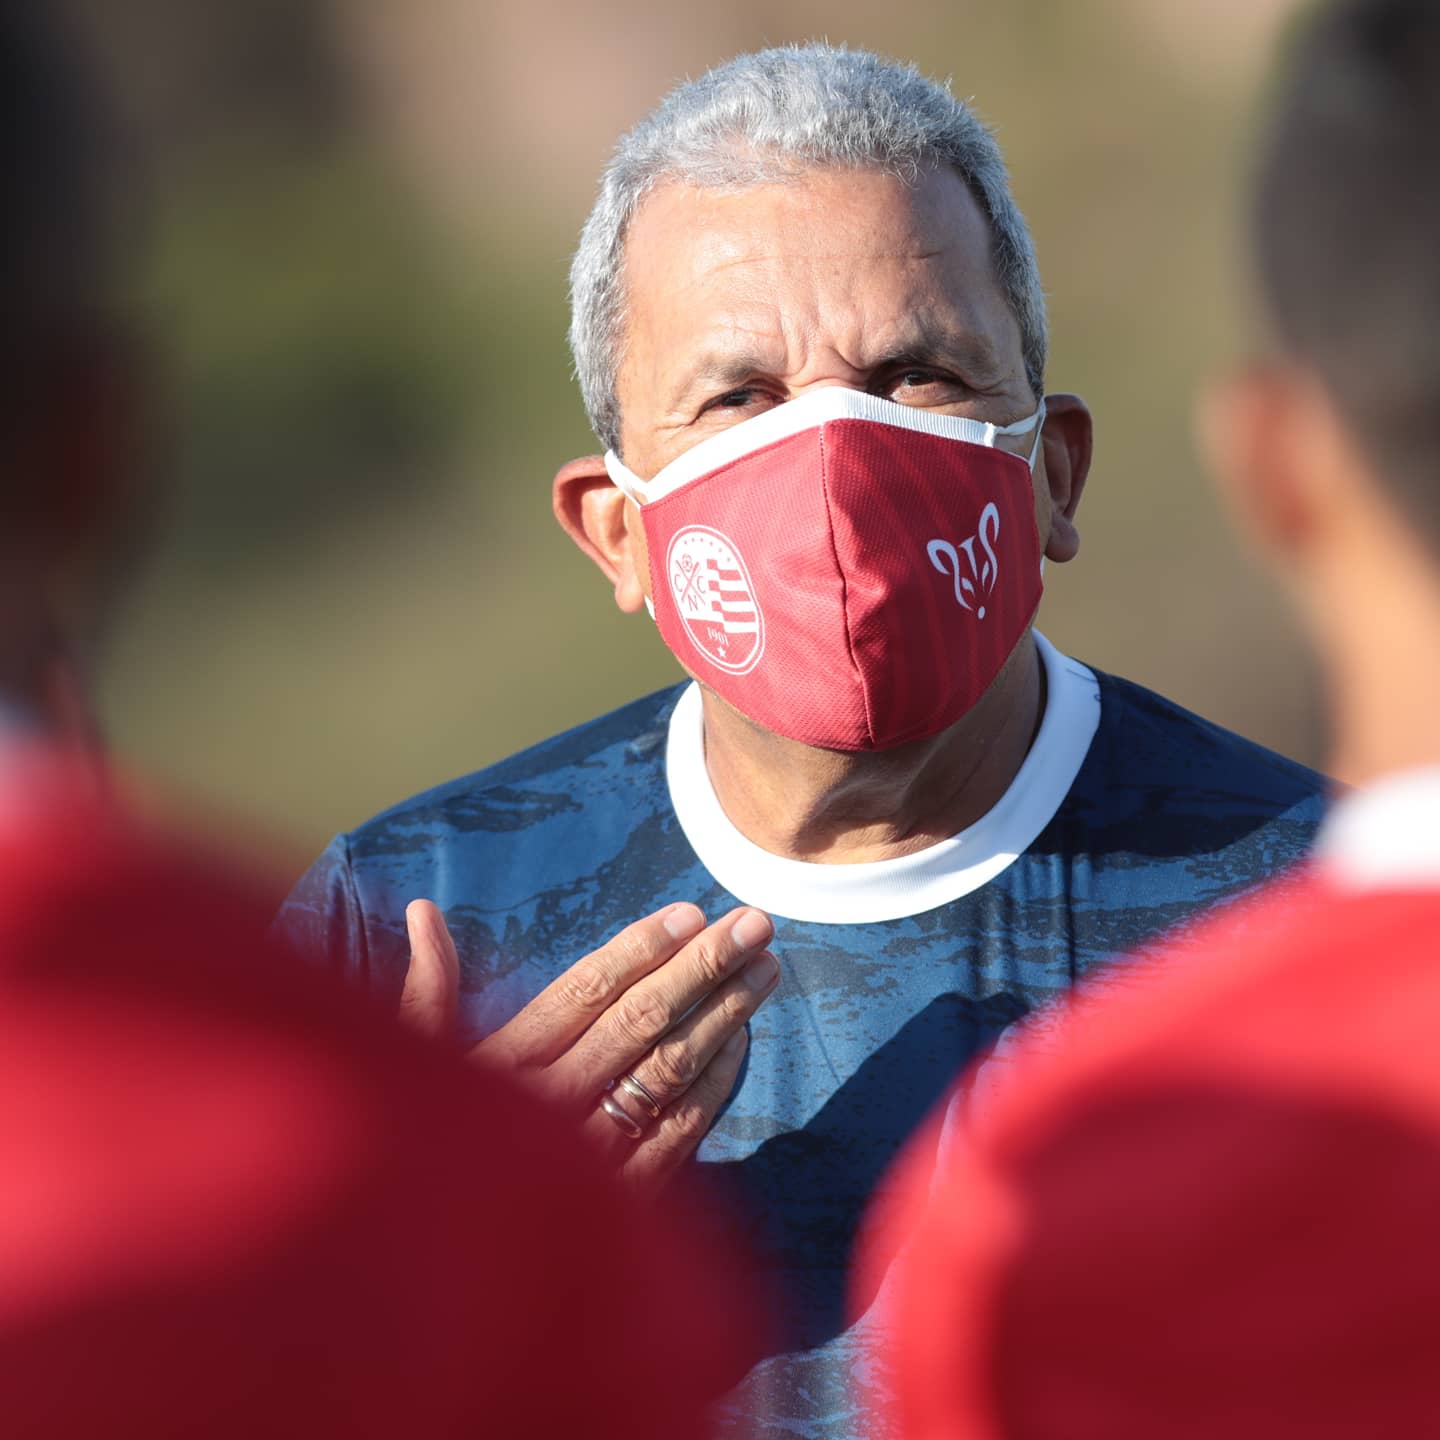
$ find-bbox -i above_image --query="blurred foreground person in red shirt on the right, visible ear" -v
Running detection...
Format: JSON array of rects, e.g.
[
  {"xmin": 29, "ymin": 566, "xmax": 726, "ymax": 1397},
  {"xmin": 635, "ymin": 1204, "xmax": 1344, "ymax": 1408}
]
[{"xmin": 858, "ymin": 0, "xmax": 1440, "ymax": 1440}]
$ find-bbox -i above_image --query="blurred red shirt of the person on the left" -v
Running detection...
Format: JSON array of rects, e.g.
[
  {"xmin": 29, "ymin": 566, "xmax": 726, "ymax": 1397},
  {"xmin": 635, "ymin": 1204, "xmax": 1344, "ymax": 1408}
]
[{"xmin": 0, "ymin": 773, "xmax": 749, "ymax": 1440}]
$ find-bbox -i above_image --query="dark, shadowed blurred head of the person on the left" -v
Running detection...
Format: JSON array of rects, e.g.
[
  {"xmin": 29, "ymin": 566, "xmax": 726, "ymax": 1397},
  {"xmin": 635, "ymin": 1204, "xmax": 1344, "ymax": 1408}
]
[{"xmin": 0, "ymin": 0, "xmax": 150, "ymax": 729}]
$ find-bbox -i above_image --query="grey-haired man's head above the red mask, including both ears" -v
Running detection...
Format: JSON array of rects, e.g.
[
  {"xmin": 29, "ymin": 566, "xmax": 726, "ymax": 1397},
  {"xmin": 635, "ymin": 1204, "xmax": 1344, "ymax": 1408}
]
[{"xmin": 556, "ymin": 43, "xmax": 1090, "ymax": 642}]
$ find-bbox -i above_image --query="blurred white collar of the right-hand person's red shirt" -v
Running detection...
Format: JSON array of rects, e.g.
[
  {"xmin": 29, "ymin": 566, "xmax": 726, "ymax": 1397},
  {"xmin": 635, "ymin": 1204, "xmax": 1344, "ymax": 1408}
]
[{"xmin": 1315, "ymin": 766, "xmax": 1440, "ymax": 890}]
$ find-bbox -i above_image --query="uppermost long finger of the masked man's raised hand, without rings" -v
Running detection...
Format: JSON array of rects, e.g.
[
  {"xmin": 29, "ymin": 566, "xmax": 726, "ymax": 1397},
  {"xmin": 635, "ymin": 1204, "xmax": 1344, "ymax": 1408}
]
[{"xmin": 477, "ymin": 903, "xmax": 706, "ymax": 1090}]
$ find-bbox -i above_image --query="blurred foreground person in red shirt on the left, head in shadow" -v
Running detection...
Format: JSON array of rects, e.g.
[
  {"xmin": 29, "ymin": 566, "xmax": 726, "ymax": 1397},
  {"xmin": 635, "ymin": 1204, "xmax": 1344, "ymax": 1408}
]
[{"xmin": 0, "ymin": 8, "xmax": 750, "ymax": 1440}]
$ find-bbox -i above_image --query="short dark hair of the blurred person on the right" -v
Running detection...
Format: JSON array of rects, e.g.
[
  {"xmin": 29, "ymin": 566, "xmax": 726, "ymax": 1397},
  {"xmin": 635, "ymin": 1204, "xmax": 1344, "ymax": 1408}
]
[{"xmin": 1253, "ymin": 0, "xmax": 1440, "ymax": 529}]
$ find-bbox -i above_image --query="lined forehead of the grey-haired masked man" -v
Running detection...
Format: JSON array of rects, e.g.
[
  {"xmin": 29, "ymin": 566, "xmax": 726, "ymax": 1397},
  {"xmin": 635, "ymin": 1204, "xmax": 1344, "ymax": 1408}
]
[{"xmin": 626, "ymin": 171, "xmax": 1018, "ymax": 402}]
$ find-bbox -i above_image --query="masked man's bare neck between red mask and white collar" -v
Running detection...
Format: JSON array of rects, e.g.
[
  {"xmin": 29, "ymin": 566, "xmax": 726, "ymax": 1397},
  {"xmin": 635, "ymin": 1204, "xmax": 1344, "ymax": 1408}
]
[{"xmin": 703, "ymin": 634, "xmax": 1045, "ymax": 864}]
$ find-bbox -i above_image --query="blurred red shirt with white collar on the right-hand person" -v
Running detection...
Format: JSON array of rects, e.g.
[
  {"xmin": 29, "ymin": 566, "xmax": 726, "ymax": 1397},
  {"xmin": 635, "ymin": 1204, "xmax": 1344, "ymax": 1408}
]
[{"xmin": 855, "ymin": 772, "xmax": 1440, "ymax": 1440}]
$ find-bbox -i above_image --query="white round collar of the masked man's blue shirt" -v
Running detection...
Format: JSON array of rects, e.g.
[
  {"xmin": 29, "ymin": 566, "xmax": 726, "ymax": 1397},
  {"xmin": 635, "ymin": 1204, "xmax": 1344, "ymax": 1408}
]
[{"xmin": 665, "ymin": 631, "xmax": 1100, "ymax": 924}]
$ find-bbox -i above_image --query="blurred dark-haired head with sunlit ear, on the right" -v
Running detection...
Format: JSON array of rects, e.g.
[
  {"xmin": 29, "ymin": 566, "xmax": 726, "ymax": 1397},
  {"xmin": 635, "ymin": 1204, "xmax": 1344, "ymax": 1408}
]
[{"xmin": 1202, "ymin": 0, "xmax": 1440, "ymax": 754}]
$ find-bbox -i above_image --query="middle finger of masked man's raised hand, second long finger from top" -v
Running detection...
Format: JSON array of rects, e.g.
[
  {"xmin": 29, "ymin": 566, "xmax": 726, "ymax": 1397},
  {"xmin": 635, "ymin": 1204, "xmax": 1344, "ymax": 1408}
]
[{"xmin": 549, "ymin": 909, "xmax": 775, "ymax": 1103}]
